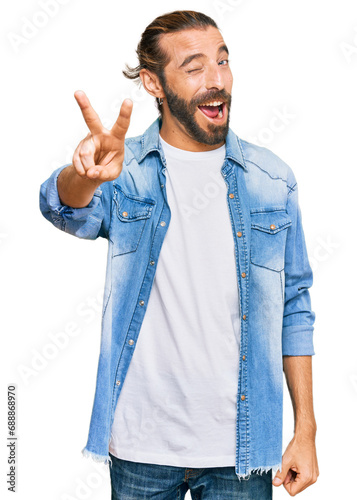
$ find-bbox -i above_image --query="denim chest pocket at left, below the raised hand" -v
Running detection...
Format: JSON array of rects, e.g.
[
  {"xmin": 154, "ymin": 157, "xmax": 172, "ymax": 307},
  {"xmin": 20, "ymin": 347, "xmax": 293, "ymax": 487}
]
[{"xmin": 110, "ymin": 186, "xmax": 155, "ymax": 257}]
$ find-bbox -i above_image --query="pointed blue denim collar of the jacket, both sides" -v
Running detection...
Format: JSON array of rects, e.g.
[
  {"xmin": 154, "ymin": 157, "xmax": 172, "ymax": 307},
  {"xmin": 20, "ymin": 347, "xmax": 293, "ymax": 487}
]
[{"xmin": 138, "ymin": 117, "xmax": 247, "ymax": 170}]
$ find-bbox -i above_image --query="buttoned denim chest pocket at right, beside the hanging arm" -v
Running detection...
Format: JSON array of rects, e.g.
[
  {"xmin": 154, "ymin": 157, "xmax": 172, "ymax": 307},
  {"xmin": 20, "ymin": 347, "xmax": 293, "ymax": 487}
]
[{"xmin": 250, "ymin": 210, "xmax": 291, "ymax": 271}]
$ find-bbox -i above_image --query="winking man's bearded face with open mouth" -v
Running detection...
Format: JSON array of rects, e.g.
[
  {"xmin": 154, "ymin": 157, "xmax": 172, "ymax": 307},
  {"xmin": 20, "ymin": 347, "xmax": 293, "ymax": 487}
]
[{"xmin": 160, "ymin": 26, "xmax": 233, "ymax": 145}]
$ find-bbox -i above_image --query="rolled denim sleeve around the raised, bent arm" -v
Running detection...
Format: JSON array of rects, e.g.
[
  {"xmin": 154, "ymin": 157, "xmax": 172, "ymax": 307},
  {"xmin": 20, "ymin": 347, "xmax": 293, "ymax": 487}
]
[{"xmin": 40, "ymin": 164, "xmax": 112, "ymax": 240}]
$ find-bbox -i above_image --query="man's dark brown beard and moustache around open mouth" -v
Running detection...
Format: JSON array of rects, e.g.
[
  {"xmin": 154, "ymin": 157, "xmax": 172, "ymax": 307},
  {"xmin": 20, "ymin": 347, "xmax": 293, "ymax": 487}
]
[{"xmin": 161, "ymin": 78, "xmax": 232, "ymax": 146}]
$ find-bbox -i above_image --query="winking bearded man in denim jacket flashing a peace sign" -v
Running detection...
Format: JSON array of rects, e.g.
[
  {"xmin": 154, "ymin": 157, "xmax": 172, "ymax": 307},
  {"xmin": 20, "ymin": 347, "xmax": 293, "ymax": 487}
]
[{"xmin": 41, "ymin": 11, "xmax": 319, "ymax": 500}]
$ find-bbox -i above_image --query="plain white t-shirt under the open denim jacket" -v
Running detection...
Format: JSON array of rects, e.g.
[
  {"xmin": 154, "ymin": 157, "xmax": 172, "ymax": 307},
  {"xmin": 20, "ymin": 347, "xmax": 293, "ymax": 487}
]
[{"xmin": 109, "ymin": 137, "xmax": 240, "ymax": 468}]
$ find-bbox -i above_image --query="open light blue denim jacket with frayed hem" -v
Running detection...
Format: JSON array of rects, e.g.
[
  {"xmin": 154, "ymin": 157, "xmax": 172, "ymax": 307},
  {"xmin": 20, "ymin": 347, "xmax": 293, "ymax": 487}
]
[{"xmin": 40, "ymin": 118, "xmax": 315, "ymax": 479}]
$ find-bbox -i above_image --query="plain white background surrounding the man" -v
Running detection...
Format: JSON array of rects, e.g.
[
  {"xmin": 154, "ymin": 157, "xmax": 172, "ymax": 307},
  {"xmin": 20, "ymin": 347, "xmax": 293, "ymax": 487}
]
[{"xmin": 0, "ymin": 0, "xmax": 357, "ymax": 500}]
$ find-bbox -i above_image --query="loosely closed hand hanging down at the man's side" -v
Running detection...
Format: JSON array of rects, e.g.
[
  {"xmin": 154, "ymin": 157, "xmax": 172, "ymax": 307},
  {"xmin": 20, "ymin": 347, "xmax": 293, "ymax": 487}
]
[{"xmin": 273, "ymin": 435, "xmax": 319, "ymax": 497}]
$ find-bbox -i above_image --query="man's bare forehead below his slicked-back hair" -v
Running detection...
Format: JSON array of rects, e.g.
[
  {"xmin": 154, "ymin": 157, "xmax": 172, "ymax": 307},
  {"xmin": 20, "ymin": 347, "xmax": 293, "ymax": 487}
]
[{"xmin": 160, "ymin": 26, "xmax": 224, "ymax": 68}]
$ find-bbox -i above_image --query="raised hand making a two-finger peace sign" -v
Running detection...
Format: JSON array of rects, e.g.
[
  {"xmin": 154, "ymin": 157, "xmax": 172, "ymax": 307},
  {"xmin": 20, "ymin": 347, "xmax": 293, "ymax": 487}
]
[{"xmin": 72, "ymin": 90, "xmax": 133, "ymax": 183}]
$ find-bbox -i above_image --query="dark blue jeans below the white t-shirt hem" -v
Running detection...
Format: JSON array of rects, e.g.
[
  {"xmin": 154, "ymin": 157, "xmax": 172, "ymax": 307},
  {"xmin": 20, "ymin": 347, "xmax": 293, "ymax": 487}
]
[{"xmin": 109, "ymin": 453, "xmax": 273, "ymax": 500}]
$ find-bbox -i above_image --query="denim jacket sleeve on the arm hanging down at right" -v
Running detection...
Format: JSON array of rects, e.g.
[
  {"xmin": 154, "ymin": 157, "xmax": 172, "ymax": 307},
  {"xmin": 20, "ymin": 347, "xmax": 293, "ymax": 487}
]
[{"xmin": 282, "ymin": 170, "xmax": 315, "ymax": 356}]
